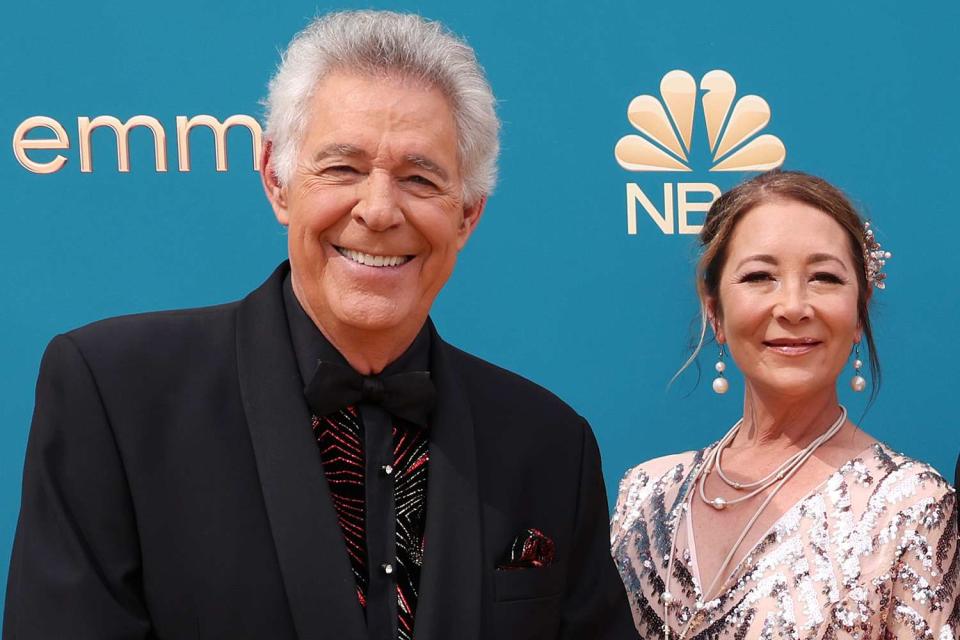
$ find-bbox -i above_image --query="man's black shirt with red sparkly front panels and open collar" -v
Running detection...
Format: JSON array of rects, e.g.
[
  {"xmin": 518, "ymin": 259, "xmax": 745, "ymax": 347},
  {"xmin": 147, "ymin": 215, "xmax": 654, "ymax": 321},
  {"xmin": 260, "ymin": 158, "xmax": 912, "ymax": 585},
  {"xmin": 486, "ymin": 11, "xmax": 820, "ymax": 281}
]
[{"xmin": 284, "ymin": 276, "xmax": 430, "ymax": 640}]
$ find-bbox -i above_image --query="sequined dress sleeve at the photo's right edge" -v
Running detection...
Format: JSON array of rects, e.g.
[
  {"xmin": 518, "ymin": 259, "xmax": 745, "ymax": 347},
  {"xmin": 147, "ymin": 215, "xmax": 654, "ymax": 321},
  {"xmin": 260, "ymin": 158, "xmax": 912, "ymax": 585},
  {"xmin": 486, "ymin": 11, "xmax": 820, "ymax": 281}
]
[{"xmin": 885, "ymin": 489, "xmax": 960, "ymax": 640}]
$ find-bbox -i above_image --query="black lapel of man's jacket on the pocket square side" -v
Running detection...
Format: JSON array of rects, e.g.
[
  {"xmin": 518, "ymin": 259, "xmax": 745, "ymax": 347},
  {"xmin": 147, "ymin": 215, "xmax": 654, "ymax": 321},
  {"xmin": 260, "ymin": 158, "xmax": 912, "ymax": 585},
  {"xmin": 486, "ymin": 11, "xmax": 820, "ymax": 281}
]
[{"xmin": 414, "ymin": 325, "xmax": 482, "ymax": 640}]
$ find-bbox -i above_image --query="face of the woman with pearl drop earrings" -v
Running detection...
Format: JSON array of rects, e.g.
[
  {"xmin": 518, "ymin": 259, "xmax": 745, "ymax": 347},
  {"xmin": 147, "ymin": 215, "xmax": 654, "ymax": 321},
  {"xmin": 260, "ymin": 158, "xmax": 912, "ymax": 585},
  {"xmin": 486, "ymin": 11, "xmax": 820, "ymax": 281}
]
[{"xmin": 708, "ymin": 200, "xmax": 860, "ymax": 398}]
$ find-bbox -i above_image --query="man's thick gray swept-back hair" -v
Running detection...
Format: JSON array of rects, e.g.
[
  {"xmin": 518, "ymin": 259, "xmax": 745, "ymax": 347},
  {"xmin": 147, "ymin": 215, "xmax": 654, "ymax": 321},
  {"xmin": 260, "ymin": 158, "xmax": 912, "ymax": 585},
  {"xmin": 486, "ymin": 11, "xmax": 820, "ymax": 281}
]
[{"xmin": 264, "ymin": 11, "xmax": 500, "ymax": 206}]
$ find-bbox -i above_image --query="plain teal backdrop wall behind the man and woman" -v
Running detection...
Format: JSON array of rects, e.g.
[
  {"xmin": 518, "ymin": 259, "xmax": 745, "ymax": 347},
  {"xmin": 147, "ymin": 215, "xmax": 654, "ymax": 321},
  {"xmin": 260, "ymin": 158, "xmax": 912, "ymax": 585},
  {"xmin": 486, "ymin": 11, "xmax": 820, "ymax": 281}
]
[{"xmin": 0, "ymin": 0, "xmax": 960, "ymax": 616}]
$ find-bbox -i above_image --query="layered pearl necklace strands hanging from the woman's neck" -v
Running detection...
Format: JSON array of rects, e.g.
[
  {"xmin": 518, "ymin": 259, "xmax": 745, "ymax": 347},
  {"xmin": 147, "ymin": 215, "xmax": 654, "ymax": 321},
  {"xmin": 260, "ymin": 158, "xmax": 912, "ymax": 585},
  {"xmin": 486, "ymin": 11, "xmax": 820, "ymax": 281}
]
[{"xmin": 660, "ymin": 405, "xmax": 847, "ymax": 640}]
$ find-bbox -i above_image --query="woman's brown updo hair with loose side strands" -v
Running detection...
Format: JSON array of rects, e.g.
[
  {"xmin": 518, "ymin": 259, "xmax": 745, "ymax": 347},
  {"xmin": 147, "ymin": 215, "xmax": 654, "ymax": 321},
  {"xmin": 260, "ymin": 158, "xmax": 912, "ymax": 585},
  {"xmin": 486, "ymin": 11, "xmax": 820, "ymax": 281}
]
[{"xmin": 681, "ymin": 169, "xmax": 881, "ymax": 402}]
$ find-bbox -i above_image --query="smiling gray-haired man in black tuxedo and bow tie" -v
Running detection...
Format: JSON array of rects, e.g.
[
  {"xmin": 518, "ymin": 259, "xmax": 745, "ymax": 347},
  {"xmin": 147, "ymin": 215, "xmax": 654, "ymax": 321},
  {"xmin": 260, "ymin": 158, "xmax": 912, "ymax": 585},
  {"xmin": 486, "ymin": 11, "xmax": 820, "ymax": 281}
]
[{"xmin": 3, "ymin": 11, "xmax": 636, "ymax": 640}]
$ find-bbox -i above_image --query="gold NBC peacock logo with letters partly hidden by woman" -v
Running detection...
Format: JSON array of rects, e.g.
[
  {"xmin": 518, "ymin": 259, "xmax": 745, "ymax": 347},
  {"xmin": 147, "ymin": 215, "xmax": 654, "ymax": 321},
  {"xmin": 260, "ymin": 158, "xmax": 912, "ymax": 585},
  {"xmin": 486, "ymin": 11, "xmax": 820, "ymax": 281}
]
[{"xmin": 614, "ymin": 69, "xmax": 787, "ymax": 235}]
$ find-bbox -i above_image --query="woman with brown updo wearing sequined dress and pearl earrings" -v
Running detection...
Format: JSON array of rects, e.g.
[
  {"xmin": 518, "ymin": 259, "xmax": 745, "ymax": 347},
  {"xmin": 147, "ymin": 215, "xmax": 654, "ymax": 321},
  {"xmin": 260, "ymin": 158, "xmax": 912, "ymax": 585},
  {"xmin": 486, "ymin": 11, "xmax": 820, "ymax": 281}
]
[{"xmin": 612, "ymin": 171, "xmax": 960, "ymax": 640}]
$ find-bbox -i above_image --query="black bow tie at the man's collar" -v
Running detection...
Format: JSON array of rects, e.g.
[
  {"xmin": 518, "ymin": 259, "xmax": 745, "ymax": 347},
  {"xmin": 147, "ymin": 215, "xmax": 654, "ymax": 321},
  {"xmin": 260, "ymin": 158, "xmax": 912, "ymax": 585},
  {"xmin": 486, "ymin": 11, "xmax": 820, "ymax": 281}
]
[{"xmin": 303, "ymin": 360, "xmax": 437, "ymax": 427}]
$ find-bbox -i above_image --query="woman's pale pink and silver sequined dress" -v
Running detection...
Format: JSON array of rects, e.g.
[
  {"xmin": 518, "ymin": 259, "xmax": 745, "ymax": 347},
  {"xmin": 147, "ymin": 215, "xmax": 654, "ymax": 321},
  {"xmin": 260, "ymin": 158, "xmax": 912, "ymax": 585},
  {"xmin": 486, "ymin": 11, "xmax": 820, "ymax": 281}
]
[{"xmin": 611, "ymin": 443, "xmax": 960, "ymax": 640}]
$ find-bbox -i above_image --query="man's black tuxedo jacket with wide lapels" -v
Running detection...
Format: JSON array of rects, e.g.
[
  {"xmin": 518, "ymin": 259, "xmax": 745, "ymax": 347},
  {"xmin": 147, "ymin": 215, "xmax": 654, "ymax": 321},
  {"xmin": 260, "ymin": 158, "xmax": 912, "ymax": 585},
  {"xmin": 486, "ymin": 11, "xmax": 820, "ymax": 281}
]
[{"xmin": 3, "ymin": 265, "xmax": 636, "ymax": 640}]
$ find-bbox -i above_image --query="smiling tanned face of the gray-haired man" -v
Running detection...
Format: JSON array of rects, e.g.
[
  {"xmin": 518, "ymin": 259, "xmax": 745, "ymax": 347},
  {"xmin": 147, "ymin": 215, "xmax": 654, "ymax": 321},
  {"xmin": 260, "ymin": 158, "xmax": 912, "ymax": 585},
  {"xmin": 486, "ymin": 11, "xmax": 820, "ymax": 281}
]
[{"xmin": 263, "ymin": 72, "xmax": 483, "ymax": 344}]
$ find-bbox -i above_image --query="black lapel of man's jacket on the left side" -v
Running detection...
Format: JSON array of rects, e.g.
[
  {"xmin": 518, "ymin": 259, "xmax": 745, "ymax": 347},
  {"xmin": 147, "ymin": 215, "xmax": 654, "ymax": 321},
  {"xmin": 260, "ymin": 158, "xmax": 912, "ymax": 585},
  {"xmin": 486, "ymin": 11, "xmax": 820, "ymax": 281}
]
[{"xmin": 237, "ymin": 263, "xmax": 366, "ymax": 640}]
